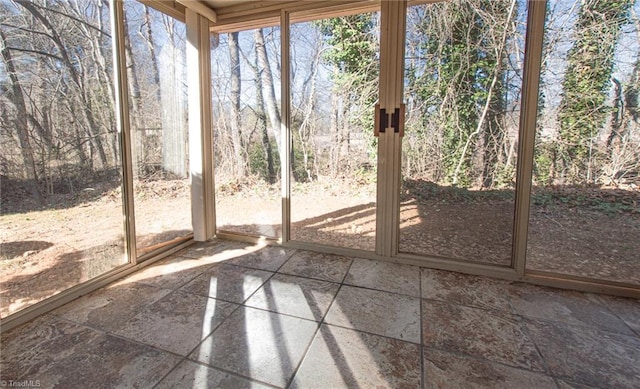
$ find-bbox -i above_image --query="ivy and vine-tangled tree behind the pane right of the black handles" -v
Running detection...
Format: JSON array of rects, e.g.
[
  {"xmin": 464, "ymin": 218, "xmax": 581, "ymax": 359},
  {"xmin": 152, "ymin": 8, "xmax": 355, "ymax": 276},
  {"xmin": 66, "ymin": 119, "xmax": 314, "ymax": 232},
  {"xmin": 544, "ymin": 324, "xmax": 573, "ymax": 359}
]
[{"xmin": 407, "ymin": 0, "xmax": 516, "ymax": 187}]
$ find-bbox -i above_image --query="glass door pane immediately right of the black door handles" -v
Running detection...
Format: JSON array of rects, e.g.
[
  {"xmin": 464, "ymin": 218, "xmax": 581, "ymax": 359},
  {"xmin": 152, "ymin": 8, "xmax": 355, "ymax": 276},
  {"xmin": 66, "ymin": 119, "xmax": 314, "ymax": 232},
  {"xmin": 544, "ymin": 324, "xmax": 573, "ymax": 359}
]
[{"xmin": 399, "ymin": 0, "xmax": 527, "ymax": 266}]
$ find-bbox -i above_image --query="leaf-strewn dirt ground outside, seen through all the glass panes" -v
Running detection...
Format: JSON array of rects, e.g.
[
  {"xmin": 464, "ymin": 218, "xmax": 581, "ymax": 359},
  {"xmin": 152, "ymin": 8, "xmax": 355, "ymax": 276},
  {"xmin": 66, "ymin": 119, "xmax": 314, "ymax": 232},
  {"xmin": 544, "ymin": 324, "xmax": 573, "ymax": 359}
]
[{"xmin": 0, "ymin": 177, "xmax": 640, "ymax": 317}]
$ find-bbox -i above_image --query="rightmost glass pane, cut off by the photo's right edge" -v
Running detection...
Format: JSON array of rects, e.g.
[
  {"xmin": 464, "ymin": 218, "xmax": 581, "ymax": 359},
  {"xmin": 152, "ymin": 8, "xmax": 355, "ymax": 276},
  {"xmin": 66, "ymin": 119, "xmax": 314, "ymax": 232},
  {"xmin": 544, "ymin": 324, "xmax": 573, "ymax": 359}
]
[{"xmin": 527, "ymin": 0, "xmax": 640, "ymax": 285}]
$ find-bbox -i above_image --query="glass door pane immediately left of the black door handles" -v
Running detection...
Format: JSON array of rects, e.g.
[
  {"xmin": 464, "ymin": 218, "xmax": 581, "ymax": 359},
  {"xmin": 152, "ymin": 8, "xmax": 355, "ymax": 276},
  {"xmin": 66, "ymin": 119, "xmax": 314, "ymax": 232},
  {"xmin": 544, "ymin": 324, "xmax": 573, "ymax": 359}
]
[{"xmin": 290, "ymin": 12, "xmax": 380, "ymax": 251}]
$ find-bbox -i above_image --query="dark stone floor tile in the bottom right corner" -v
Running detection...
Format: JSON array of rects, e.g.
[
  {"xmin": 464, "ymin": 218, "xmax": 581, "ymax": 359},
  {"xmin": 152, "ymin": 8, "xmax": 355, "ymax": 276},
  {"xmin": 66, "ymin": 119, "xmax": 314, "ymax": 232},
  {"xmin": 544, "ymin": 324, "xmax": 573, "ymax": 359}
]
[{"xmin": 526, "ymin": 320, "xmax": 640, "ymax": 388}]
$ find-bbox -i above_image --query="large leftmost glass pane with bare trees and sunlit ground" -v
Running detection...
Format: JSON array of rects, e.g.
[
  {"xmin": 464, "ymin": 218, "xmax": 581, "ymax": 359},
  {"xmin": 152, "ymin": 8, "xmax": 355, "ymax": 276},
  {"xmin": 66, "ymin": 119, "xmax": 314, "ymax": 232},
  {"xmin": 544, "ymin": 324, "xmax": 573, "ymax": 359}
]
[{"xmin": 0, "ymin": 0, "xmax": 126, "ymax": 318}]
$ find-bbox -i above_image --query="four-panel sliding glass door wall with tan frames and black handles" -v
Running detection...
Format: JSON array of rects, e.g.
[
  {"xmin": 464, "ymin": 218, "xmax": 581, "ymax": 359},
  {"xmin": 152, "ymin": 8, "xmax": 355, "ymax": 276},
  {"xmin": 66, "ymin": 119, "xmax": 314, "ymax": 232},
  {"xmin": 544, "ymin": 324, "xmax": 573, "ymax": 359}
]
[{"xmin": 206, "ymin": 0, "xmax": 640, "ymax": 294}]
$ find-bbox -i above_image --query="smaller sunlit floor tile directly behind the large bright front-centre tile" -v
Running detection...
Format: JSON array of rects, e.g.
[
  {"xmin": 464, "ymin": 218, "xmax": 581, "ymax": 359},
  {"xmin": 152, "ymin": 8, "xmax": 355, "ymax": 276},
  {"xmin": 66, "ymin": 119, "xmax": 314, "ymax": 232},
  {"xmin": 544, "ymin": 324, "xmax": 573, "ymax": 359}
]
[{"xmin": 245, "ymin": 274, "xmax": 340, "ymax": 321}]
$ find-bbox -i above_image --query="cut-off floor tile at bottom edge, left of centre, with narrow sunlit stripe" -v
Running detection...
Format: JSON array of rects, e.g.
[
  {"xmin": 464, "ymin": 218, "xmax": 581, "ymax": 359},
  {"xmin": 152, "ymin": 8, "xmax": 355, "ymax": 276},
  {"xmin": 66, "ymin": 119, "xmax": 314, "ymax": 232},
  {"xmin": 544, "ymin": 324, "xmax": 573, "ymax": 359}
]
[{"xmin": 156, "ymin": 360, "xmax": 271, "ymax": 389}]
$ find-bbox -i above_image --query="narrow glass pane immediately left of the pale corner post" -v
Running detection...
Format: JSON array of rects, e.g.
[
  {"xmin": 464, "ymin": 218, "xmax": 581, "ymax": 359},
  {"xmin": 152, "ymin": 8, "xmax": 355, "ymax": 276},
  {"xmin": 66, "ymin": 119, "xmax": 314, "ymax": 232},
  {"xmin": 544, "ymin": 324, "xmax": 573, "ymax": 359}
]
[{"xmin": 124, "ymin": 0, "xmax": 192, "ymax": 256}]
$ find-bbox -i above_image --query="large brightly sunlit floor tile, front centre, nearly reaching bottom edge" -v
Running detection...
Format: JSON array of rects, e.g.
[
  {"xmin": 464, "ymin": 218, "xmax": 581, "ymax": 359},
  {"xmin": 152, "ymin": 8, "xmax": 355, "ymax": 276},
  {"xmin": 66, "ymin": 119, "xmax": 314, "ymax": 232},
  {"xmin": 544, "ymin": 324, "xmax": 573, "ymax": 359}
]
[{"xmin": 190, "ymin": 307, "xmax": 318, "ymax": 387}]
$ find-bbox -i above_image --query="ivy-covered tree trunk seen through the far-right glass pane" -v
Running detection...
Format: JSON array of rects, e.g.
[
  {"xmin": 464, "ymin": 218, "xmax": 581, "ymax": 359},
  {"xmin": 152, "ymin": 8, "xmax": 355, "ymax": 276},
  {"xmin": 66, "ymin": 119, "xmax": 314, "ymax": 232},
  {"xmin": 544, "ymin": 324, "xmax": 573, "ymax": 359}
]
[{"xmin": 556, "ymin": 0, "xmax": 633, "ymax": 183}]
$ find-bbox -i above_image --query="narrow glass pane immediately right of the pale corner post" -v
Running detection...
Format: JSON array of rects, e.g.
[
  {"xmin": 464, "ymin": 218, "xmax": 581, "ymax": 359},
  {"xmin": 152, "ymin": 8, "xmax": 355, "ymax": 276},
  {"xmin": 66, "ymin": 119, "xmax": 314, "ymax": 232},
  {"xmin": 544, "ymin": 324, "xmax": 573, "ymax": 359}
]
[{"xmin": 211, "ymin": 27, "xmax": 282, "ymax": 238}]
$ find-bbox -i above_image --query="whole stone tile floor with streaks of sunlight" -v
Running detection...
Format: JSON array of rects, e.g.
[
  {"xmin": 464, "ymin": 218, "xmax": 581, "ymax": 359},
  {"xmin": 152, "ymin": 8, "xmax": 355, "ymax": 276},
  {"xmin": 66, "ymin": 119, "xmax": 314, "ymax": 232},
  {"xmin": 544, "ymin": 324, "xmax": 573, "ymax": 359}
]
[{"xmin": 0, "ymin": 241, "xmax": 640, "ymax": 388}]
